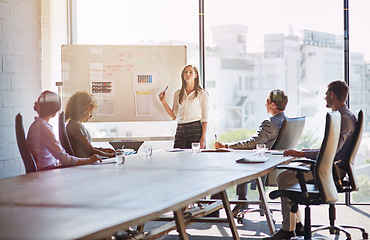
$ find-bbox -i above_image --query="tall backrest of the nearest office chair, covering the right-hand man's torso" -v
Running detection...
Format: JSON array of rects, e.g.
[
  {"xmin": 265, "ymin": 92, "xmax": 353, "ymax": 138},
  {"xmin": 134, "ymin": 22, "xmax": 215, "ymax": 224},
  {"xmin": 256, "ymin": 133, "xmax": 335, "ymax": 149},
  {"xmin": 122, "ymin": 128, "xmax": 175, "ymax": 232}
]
[{"xmin": 313, "ymin": 111, "xmax": 341, "ymax": 203}]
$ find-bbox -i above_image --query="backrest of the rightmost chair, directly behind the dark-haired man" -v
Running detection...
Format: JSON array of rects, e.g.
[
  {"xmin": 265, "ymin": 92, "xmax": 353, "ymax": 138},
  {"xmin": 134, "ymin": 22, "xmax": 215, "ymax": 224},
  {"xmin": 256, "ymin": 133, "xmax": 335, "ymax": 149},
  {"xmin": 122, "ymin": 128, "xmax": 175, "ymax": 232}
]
[{"xmin": 345, "ymin": 110, "xmax": 364, "ymax": 191}]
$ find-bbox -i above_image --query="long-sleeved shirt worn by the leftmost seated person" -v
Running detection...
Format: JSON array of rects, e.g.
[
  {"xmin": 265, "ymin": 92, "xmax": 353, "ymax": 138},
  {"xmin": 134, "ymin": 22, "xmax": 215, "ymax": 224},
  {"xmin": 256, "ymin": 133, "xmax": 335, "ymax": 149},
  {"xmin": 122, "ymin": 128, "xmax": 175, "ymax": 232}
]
[{"xmin": 27, "ymin": 117, "xmax": 78, "ymax": 170}]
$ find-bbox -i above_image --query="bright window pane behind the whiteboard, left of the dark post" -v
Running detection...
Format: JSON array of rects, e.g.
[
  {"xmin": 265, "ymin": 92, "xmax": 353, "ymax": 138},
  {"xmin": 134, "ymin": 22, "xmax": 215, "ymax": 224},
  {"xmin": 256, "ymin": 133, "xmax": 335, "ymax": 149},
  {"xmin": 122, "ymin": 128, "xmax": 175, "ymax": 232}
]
[{"xmin": 74, "ymin": 0, "xmax": 199, "ymax": 148}]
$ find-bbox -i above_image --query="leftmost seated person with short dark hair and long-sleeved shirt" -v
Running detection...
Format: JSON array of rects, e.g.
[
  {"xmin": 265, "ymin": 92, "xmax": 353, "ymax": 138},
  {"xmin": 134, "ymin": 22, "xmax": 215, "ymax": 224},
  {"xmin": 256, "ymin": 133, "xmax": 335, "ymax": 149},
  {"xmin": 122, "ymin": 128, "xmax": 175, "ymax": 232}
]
[{"xmin": 27, "ymin": 91, "xmax": 101, "ymax": 170}]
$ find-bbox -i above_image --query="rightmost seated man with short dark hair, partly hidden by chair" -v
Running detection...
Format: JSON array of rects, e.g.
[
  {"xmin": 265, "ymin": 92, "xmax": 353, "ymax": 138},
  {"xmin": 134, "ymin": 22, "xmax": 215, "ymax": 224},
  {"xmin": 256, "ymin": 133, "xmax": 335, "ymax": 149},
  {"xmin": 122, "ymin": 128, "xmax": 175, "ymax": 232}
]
[{"xmin": 264, "ymin": 81, "xmax": 357, "ymax": 240}]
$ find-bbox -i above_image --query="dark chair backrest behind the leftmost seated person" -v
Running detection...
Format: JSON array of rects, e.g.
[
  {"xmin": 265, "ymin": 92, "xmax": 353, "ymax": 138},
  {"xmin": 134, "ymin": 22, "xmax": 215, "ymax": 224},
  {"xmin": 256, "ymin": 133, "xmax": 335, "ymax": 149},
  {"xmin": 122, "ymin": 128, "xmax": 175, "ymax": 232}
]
[{"xmin": 15, "ymin": 113, "xmax": 37, "ymax": 173}]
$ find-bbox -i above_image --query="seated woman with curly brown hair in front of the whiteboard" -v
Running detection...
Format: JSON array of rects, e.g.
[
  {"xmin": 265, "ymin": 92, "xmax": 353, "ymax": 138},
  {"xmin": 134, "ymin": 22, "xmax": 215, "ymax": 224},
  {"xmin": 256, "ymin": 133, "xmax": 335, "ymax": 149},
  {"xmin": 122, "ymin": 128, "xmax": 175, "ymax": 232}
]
[{"xmin": 65, "ymin": 91, "xmax": 115, "ymax": 157}]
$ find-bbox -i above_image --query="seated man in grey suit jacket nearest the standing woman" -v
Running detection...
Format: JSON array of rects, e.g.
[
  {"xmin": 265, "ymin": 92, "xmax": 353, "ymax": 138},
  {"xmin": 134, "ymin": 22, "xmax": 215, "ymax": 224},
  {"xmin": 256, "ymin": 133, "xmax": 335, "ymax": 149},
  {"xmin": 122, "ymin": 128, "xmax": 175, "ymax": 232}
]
[{"xmin": 215, "ymin": 89, "xmax": 288, "ymax": 211}]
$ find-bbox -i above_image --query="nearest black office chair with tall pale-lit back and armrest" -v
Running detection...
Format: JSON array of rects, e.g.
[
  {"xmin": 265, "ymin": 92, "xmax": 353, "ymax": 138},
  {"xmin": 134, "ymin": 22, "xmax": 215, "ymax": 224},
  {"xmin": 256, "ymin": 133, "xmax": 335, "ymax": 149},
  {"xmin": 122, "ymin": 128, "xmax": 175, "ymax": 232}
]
[{"xmin": 270, "ymin": 111, "xmax": 341, "ymax": 239}]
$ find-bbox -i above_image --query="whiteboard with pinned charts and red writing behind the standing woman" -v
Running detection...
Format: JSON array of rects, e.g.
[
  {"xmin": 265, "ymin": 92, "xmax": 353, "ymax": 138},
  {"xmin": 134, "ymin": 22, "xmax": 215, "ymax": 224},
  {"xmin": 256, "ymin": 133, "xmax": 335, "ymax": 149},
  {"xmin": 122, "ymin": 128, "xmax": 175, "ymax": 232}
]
[{"xmin": 61, "ymin": 45, "xmax": 187, "ymax": 122}]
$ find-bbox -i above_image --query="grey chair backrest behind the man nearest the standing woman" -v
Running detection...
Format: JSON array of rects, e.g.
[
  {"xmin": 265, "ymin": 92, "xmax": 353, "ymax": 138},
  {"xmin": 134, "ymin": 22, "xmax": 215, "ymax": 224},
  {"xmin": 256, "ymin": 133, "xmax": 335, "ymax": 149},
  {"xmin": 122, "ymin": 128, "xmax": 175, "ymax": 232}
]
[{"xmin": 271, "ymin": 116, "xmax": 306, "ymax": 150}]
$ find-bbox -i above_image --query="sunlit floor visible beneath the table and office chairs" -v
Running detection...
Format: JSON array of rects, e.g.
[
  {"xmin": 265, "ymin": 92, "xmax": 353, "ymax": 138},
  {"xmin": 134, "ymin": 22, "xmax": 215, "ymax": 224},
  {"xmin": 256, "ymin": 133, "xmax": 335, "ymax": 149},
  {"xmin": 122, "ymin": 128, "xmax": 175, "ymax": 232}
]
[{"xmin": 144, "ymin": 203, "xmax": 370, "ymax": 240}]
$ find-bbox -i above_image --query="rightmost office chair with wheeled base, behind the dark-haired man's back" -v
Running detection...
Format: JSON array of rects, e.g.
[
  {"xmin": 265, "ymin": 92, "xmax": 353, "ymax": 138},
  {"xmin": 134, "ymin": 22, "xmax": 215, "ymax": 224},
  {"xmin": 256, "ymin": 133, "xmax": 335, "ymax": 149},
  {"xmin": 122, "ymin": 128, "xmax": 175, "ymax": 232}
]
[{"xmin": 312, "ymin": 110, "xmax": 369, "ymax": 239}]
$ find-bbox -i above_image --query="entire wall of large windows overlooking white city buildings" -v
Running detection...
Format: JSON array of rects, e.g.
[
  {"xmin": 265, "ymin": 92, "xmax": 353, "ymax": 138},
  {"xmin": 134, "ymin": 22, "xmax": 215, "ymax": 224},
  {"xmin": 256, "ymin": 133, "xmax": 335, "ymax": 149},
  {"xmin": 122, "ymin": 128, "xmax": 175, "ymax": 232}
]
[{"xmin": 74, "ymin": 0, "xmax": 370, "ymax": 202}]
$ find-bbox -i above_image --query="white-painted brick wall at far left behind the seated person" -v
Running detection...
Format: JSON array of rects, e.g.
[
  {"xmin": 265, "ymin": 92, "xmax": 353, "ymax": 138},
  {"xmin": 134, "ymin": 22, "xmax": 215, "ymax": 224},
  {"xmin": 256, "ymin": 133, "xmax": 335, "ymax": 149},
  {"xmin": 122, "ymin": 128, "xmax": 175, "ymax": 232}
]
[{"xmin": 0, "ymin": 0, "xmax": 41, "ymax": 179}]
